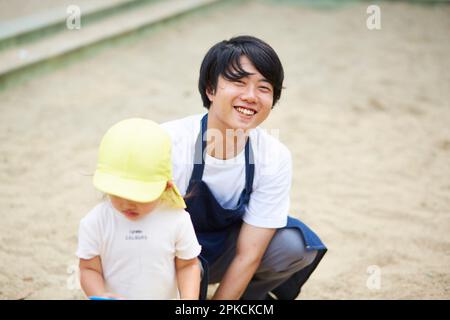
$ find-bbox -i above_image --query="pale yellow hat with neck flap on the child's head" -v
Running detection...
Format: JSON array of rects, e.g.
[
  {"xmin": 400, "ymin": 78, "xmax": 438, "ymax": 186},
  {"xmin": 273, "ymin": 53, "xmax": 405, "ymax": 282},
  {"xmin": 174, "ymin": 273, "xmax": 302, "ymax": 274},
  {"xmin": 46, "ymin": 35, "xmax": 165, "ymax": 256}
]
[{"xmin": 93, "ymin": 118, "xmax": 186, "ymax": 208}]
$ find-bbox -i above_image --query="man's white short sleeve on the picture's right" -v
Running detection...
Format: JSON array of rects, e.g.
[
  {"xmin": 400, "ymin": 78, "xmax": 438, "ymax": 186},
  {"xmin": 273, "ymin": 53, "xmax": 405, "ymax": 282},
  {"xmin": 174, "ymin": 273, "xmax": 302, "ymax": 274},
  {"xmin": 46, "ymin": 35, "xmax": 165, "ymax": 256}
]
[{"xmin": 243, "ymin": 145, "xmax": 292, "ymax": 228}]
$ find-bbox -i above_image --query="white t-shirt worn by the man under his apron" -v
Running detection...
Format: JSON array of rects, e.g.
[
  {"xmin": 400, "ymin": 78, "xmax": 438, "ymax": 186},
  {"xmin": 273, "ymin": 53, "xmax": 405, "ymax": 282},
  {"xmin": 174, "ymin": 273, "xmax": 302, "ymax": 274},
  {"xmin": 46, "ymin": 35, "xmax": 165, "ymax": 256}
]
[{"xmin": 162, "ymin": 114, "xmax": 292, "ymax": 228}]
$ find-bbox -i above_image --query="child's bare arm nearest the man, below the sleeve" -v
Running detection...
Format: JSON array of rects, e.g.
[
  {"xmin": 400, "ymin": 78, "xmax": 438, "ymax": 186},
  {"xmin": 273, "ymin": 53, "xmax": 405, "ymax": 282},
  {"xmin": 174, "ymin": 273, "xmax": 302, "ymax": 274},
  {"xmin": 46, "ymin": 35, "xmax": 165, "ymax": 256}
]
[{"xmin": 175, "ymin": 257, "xmax": 201, "ymax": 300}]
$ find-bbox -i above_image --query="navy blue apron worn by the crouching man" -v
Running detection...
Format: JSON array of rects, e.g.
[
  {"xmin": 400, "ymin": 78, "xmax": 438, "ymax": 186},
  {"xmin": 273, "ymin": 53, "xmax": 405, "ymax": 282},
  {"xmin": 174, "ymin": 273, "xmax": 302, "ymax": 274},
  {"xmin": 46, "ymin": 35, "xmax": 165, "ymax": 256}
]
[{"xmin": 185, "ymin": 114, "xmax": 326, "ymax": 299}]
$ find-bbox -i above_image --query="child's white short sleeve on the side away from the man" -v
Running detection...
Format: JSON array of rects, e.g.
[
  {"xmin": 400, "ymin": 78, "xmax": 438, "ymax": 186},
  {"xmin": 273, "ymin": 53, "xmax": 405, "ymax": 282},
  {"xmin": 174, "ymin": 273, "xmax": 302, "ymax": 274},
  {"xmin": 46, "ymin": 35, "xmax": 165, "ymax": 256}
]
[{"xmin": 76, "ymin": 212, "xmax": 101, "ymax": 260}]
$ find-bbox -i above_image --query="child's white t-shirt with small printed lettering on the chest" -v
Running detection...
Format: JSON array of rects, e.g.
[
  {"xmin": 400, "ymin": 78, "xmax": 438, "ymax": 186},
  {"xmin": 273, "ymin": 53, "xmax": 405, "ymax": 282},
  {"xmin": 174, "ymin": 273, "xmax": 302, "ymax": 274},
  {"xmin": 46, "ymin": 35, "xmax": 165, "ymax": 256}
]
[{"xmin": 76, "ymin": 200, "xmax": 201, "ymax": 300}]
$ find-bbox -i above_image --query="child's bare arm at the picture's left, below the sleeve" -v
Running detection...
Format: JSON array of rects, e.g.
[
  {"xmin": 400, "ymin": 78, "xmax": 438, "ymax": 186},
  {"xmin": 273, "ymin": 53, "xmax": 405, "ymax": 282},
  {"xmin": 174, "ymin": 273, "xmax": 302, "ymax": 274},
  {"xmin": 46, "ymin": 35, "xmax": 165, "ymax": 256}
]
[{"xmin": 80, "ymin": 256, "xmax": 120, "ymax": 298}]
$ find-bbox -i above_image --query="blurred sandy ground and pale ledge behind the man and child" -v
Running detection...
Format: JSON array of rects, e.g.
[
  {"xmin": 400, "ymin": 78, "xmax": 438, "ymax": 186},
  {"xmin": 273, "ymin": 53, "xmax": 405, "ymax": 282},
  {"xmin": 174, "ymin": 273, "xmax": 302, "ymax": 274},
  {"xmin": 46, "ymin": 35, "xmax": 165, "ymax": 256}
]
[{"xmin": 0, "ymin": 0, "xmax": 450, "ymax": 299}]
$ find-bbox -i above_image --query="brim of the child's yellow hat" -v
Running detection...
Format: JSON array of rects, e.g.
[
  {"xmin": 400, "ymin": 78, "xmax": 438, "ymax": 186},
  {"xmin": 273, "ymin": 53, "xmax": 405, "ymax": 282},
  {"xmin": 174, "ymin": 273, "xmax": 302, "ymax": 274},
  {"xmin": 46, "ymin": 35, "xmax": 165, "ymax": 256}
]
[{"xmin": 93, "ymin": 170, "xmax": 167, "ymax": 202}]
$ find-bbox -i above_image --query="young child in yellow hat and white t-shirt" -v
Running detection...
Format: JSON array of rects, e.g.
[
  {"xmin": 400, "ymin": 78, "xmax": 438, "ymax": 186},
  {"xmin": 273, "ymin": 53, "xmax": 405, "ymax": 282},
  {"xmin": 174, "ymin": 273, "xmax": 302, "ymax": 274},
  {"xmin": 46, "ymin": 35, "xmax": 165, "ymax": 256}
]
[{"xmin": 77, "ymin": 118, "xmax": 201, "ymax": 299}]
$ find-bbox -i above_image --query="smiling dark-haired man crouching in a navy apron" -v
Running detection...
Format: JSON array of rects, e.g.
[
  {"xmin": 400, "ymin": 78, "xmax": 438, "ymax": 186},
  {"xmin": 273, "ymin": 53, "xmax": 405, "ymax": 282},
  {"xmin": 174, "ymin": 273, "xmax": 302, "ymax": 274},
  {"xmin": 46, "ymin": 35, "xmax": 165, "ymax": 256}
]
[{"xmin": 163, "ymin": 36, "xmax": 326, "ymax": 299}]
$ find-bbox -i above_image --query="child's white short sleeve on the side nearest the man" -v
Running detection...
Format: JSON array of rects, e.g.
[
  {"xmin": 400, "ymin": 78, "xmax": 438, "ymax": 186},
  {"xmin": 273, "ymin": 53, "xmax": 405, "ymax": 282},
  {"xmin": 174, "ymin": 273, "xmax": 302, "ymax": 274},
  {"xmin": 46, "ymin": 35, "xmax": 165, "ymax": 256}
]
[{"xmin": 175, "ymin": 211, "xmax": 202, "ymax": 260}]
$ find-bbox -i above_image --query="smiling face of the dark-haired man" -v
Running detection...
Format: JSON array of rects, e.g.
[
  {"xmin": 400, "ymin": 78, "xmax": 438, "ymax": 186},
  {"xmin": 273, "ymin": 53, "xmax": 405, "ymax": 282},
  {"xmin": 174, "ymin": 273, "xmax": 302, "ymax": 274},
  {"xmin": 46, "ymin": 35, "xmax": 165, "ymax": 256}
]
[{"xmin": 207, "ymin": 56, "xmax": 273, "ymax": 131}]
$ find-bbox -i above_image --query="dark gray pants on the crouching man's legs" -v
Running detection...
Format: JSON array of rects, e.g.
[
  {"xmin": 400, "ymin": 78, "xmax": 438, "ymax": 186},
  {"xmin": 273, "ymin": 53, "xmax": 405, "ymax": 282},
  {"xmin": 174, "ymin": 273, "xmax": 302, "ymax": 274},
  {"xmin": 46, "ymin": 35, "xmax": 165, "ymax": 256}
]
[{"xmin": 208, "ymin": 228, "xmax": 317, "ymax": 300}]
